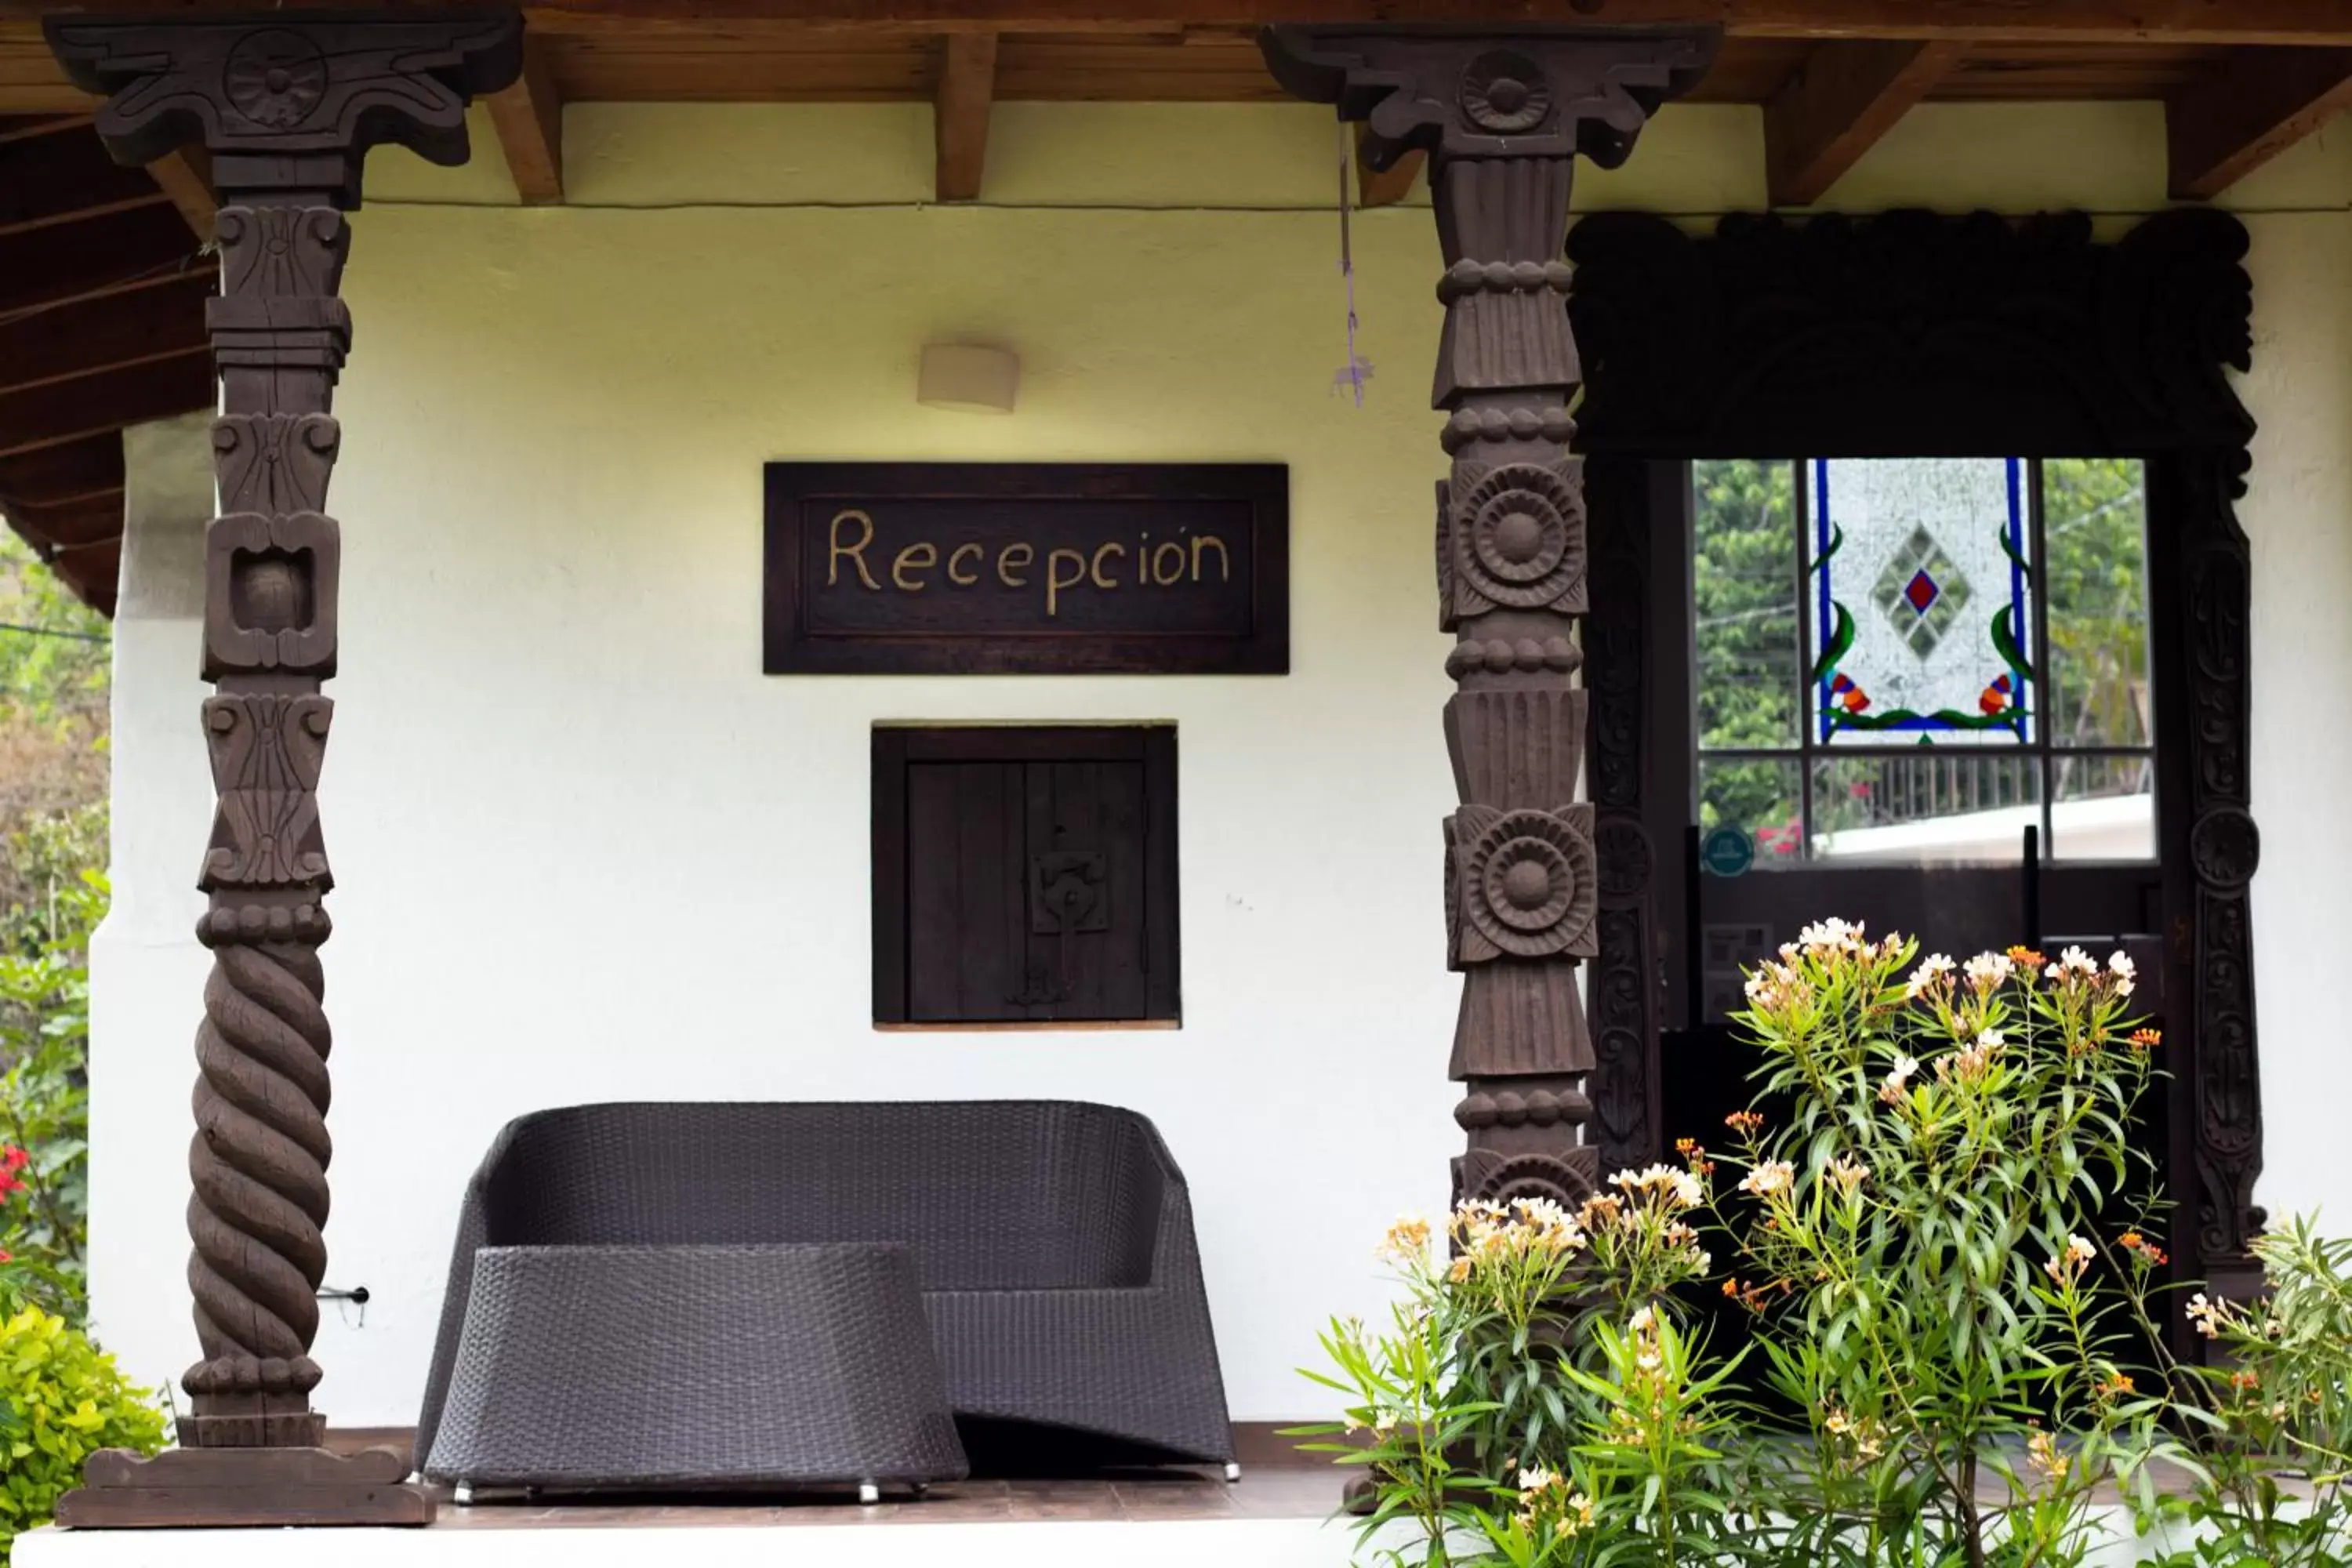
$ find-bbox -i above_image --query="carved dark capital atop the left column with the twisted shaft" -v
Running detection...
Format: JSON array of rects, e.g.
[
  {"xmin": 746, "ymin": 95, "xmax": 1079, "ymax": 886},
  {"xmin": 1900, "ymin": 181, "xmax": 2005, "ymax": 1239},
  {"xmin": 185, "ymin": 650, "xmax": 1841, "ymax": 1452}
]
[{"xmin": 42, "ymin": 9, "xmax": 522, "ymax": 207}]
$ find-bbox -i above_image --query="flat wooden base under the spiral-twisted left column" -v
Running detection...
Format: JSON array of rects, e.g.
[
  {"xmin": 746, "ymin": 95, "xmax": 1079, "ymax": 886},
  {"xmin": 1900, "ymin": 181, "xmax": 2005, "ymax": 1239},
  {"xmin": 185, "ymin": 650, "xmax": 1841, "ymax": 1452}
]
[{"xmin": 56, "ymin": 1448, "xmax": 435, "ymax": 1530}]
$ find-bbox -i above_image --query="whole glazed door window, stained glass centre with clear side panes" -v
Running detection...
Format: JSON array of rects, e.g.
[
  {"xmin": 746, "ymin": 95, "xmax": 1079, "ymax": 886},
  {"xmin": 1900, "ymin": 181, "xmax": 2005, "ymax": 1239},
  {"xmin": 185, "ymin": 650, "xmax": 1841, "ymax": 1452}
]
[{"xmin": 1691, "ymin": 459, "xmax": 2154, "ymax": 869}]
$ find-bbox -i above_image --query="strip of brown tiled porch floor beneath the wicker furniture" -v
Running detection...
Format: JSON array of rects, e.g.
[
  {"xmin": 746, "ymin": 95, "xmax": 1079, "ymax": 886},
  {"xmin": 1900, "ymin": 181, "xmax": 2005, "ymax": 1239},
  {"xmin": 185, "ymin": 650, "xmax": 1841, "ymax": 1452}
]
[{"xmin": 435, "ymin": 1465, "xmax": 1352, "ymax": 1530}]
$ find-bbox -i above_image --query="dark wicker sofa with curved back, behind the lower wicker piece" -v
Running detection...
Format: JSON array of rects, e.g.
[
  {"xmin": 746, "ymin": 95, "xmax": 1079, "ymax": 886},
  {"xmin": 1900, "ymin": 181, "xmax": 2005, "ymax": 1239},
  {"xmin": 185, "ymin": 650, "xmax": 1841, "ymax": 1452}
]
[{"xmin": 416, "ymin": 1100, "xmax": 1232, "ymax": 1479}]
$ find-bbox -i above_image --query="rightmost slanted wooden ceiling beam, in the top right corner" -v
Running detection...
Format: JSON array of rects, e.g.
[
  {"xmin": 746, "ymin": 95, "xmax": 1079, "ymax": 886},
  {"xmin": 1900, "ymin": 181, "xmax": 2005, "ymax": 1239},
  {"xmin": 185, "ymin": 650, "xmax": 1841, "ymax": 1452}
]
[{"xmin": 2164, "ymin": 47, "xmax": 2352, "ymax": 200}]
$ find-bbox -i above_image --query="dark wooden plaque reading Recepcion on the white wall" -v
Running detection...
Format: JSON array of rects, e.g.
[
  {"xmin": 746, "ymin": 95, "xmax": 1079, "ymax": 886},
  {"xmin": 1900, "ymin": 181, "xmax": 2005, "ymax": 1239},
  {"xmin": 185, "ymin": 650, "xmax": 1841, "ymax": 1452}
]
[{"xmin": 764, "ymin": 463, "xmax": 1291, "ymax": 675}]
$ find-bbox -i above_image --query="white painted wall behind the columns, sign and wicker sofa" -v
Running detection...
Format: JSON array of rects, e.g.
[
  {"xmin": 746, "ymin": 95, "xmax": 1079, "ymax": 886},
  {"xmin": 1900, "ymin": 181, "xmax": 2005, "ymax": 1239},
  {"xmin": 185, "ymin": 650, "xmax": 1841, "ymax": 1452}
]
[{"xmin": 94, "ymin": 92, "xmax": 2352, "ymax": 1425}]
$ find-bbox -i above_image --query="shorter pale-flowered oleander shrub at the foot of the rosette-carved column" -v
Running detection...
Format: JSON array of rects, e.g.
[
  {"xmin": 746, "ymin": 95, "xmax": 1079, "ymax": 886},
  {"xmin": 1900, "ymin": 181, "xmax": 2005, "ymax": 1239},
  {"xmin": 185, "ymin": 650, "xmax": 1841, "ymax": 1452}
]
[{"xmin": 1301, "ymin": 1189, "xmax": 1731, "ymax": 1568}]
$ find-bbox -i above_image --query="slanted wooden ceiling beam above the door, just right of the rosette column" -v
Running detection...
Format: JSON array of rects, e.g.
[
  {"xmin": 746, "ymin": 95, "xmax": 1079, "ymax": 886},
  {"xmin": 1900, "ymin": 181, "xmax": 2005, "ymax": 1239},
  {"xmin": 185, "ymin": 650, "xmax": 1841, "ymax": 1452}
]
[{"xmin": 1764, "ymin": 40, "xmax": 1969, "ymax": 207}]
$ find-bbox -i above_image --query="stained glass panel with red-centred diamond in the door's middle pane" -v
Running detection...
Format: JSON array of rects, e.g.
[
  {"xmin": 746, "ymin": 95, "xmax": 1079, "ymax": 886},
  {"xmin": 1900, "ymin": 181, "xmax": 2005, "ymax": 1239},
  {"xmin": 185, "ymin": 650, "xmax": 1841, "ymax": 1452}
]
[{"xmin": 1806, "ymin": 459, "xmax": 2034, "ymax": 746}]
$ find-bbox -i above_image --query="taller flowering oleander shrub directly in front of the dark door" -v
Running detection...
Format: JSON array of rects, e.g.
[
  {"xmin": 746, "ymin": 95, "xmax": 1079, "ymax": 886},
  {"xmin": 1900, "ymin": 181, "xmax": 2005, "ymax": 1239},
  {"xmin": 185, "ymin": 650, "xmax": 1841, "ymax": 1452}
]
[{"xmin": 1686, "ymin": 919, "xmax": 2178, "ymax": 1568}]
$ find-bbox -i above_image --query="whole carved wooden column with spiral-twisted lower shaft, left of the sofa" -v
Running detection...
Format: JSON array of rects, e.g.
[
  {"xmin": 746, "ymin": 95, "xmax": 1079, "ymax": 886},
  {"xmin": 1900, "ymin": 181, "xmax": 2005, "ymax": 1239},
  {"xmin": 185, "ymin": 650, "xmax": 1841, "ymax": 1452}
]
[{"xmin": 47, "ymin": 12, "xmax": 522, "ymax": 1526}]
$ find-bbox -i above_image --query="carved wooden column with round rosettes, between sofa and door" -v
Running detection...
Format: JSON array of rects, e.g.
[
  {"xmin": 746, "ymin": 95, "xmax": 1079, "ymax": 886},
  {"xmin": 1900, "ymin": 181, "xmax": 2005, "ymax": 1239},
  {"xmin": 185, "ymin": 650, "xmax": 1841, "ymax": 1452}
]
[{"xmin": 1263, "ymin": 26, "xmax": 1717, "ymax": 1206}]
